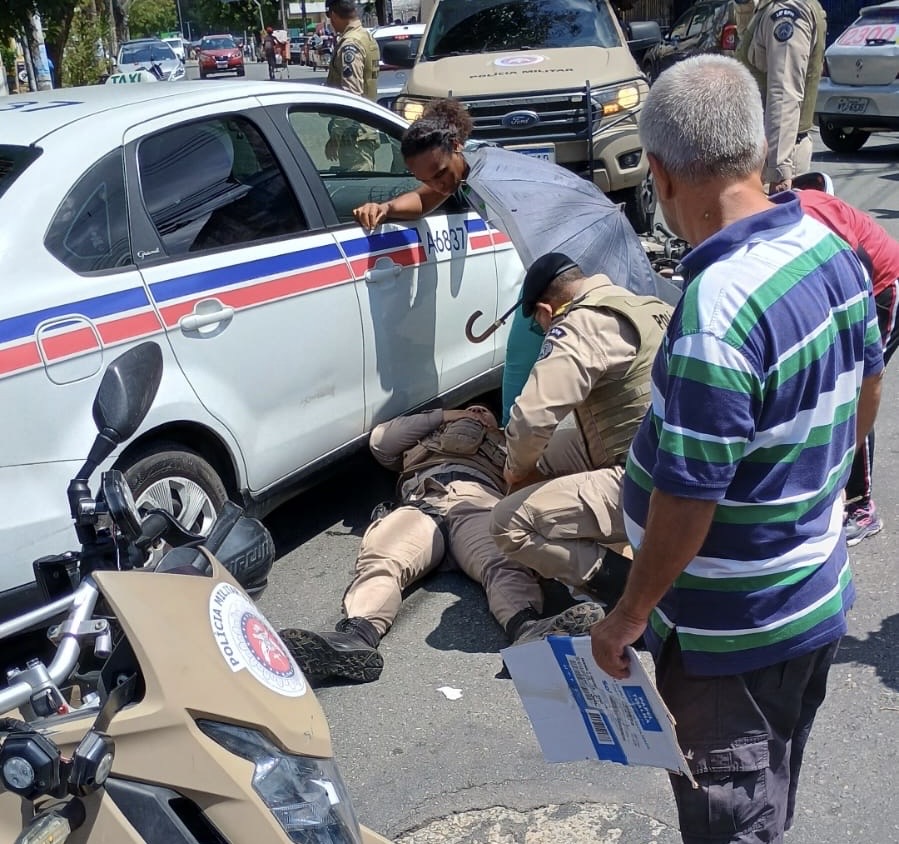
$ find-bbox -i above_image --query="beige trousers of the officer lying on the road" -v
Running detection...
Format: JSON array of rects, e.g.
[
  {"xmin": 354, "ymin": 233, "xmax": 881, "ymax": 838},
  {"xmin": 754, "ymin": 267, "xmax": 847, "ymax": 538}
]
[{"xmin": 343, "ymin": 481, "xmax": 543, "ymax": 636}]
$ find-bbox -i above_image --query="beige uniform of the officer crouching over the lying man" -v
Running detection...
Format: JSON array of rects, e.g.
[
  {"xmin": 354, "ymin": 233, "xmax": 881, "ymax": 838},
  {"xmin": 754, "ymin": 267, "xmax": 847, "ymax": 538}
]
[{"xmin": 491, "ymin": 275, "xmax": 671, "ymax": 586}]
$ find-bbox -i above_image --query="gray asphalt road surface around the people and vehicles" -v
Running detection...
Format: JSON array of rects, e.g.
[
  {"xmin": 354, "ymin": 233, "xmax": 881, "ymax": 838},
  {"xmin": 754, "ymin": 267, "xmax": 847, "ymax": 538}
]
[{"xmin": 246, "ymin": 123, "xmax": 899, "ymax": 844}]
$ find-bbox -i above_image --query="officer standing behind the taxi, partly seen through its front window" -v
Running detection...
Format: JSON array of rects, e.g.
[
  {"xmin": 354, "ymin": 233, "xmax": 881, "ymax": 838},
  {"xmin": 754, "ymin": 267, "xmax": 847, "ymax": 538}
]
[{"xmin": 325, "ymin": 0, "xmax": 381, "ymax": 171}]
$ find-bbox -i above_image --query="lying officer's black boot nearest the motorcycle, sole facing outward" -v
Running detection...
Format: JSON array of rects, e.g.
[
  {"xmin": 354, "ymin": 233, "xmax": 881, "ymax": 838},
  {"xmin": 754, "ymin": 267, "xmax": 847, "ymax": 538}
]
[{"xmin": 279, "ymin": 618, "xmax": 384, "ymax": 683}]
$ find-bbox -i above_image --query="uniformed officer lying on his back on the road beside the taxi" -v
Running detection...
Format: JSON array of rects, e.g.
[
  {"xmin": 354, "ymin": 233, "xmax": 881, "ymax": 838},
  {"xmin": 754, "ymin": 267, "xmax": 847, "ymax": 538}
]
[{"xmin": 281, "ymin": 405, "xmax": 603, "ymax": 682}]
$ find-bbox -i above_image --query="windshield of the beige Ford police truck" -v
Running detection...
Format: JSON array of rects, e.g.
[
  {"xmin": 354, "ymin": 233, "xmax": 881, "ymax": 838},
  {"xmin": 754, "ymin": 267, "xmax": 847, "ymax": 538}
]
[{"xmin": 421, "ymin": 0, "xmax": 621, "ymax": 61}]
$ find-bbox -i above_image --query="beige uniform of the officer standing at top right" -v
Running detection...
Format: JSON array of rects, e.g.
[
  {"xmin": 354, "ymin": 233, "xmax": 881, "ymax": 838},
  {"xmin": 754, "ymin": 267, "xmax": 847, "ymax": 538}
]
[{"xmin": 737, "ymin": 0, "xmax": 827, "ymax": 184}]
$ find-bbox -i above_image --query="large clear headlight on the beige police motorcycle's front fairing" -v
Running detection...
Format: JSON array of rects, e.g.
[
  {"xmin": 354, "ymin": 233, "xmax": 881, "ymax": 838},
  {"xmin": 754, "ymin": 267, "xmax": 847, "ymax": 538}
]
[{"xmin": 197, "ymin": 720, "xmax": 362, "ymax": 844}]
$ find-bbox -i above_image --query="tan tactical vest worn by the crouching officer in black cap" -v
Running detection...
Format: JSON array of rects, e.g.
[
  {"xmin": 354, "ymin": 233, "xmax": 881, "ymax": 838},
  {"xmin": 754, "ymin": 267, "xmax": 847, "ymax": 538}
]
[{"xmin": 563, "ymin": 285, "xmax": 671, "ymax": 469}]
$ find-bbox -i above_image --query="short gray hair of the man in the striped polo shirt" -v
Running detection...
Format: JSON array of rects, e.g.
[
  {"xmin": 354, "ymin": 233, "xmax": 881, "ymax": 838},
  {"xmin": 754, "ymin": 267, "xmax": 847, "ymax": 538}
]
[{"xmin": 640, "ymin": 55, "xmax": 766, "ymax": 181}]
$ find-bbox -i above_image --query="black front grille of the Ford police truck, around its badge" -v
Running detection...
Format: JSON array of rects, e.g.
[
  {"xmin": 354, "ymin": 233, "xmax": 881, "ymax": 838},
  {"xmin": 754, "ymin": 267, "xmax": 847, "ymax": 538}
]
[{"xmin": 463, "ymin": 90, "xmax": 588, "ymax": 144}]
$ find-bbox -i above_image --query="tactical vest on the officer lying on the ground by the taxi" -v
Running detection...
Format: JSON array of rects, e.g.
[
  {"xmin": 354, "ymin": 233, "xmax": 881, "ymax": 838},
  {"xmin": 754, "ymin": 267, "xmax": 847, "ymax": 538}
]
[{"xmin": 399, "ymin": 419, "xmax": 506, "ymax": 489}]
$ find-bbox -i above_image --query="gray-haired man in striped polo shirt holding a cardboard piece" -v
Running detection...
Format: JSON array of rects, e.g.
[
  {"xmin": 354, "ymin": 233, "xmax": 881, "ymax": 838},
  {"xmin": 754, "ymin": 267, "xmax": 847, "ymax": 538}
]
[{"xmin": 592, "ymin": 55, "xmax": 883, "ymax": 844}]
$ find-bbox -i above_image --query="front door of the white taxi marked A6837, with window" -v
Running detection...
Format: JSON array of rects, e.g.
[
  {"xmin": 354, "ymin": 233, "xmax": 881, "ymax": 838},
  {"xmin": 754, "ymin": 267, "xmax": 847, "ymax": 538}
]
[{"xmin": 278, "ymin": 105, "xmax": 497, "ymax": 427}]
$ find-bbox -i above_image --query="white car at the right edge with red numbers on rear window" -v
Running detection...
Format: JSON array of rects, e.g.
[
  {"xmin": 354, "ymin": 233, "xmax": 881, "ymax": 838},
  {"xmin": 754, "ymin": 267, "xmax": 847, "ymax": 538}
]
[{"xmin": 815, "ymin": 2, "xmax": 899, "ymax": 153}]
